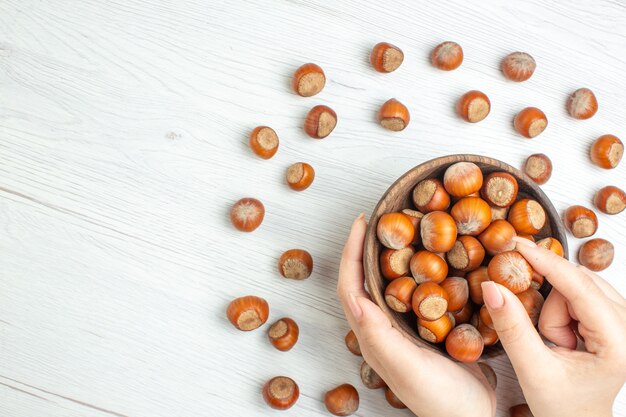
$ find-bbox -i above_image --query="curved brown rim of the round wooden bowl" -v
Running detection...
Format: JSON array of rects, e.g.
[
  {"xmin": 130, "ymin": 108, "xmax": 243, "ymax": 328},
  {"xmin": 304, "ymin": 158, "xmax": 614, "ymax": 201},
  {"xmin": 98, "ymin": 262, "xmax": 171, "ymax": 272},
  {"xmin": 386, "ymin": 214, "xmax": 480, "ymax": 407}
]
[{"xmin": 363, "ymin": 154, "xmax": 569, "ymax": 357}]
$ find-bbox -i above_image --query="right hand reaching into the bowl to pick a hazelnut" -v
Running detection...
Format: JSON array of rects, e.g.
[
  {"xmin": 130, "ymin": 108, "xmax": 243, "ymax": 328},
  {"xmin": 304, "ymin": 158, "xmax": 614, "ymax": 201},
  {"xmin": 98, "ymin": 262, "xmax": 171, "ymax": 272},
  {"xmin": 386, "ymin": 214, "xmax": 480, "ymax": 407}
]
[{"xmin": 482, "ymin": 238, "xmax": 626, "ymax": 417}]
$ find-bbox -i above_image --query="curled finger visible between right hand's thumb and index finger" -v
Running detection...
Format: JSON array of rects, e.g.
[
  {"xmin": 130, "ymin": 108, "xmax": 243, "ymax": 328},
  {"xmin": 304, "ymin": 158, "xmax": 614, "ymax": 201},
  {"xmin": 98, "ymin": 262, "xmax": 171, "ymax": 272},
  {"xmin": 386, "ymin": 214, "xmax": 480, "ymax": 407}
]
[{"xmin": 539, "ymin": 289, "xmax": 578, "ymax": 349}]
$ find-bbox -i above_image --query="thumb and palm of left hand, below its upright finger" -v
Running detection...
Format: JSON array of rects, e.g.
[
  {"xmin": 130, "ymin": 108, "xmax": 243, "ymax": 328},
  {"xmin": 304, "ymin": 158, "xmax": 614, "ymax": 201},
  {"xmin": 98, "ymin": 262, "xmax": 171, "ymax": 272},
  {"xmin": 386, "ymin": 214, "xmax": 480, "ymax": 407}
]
[{"xmin": 353, "ymin": 297, "xmax": 495, "ymax": 417}]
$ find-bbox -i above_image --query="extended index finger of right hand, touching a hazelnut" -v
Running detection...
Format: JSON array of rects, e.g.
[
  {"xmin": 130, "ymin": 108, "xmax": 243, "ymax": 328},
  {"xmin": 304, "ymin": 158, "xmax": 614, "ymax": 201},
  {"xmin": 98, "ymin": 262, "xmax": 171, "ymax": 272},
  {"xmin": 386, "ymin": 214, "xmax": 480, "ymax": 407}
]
[{"xmin": 513, "ymin": 237, "xmax": 612, "ymax": 330}]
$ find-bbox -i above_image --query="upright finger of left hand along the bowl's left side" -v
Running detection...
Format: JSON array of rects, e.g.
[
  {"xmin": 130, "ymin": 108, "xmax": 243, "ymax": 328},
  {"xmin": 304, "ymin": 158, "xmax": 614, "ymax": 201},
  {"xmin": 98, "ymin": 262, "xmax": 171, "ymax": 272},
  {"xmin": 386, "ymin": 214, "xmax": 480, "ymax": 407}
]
[{"xmin": 337, "ymin": 214, "xmax": 367, "ymax": 303}]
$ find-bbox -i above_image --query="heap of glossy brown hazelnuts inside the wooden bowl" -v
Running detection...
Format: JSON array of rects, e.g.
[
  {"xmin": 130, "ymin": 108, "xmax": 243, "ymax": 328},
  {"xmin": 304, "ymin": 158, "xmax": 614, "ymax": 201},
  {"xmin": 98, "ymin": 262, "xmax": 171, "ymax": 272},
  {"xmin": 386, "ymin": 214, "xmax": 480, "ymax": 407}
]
[{"xmin": 376, "ymin": 162, "xmax": 563, "ymax": 362}]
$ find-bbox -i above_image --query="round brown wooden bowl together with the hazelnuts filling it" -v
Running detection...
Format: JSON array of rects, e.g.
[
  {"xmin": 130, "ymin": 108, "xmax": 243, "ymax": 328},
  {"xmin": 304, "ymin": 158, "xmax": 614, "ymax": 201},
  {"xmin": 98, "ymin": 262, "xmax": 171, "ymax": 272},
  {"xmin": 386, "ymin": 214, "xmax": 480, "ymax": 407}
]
[{"xmin": 363, "ymin": 155, "xmax": 568, "ymax": 362}]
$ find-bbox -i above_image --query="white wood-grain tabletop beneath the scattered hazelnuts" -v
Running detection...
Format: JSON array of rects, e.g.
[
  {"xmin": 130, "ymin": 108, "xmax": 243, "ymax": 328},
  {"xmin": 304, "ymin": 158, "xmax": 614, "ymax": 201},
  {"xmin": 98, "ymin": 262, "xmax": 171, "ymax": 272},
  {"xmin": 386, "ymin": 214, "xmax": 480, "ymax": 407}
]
[{"xmin": 0, "ymin": 0, "xmax": 626, "ymax": 417}]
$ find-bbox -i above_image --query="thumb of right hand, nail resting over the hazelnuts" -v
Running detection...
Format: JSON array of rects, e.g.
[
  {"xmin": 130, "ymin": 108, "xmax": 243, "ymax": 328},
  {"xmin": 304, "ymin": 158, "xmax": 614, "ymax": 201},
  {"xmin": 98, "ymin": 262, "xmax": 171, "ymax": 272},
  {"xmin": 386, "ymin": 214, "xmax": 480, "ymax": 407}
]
[{"xmin": 481, "ymin": 281, "xmax": 548, "ymax": 380}]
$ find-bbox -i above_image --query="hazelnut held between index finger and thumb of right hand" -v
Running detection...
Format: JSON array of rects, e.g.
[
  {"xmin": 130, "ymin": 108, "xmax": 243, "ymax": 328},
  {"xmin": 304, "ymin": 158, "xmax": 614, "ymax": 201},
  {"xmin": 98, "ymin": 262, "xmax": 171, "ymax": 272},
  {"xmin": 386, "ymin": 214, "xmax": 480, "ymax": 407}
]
[{"xmin": 487, "ymin": 251, "xmax": 533, "ymax": 294}]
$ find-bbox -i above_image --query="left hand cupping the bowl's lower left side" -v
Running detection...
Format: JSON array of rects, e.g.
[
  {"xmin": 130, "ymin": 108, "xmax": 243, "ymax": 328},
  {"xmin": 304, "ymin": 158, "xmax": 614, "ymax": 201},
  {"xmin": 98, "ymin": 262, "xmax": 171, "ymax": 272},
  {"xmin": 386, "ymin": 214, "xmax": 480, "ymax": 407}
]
[{"xmin": 337, "ymin": 215, "xmax": 496, "ymax": 417}]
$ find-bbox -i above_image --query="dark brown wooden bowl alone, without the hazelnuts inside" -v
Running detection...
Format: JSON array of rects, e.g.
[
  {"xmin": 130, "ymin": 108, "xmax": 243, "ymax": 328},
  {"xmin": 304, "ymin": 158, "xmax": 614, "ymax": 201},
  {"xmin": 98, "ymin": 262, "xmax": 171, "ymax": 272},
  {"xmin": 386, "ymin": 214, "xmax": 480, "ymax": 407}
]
[{"xmin": 363, "ymin": 155, "xmax": 568, "ymax": 357}]
